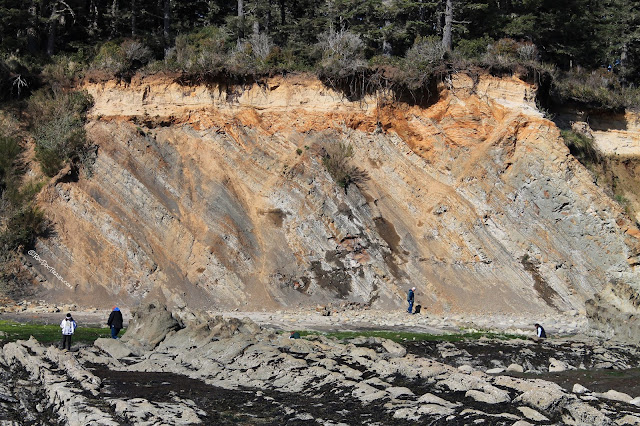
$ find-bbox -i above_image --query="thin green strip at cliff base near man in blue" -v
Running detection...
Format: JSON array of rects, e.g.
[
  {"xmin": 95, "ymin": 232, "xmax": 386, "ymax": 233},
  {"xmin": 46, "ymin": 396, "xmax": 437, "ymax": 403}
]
[{"xmin": 300, "ymin": 330, "xmax": 525, "ymax": 343}]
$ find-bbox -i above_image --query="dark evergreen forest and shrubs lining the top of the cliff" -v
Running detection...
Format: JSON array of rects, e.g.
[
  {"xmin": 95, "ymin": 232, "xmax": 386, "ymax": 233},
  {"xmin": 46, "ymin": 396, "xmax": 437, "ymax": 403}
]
[{"xmin": 0, "ymin": 0, "xmax": 640, "ymax": 109}]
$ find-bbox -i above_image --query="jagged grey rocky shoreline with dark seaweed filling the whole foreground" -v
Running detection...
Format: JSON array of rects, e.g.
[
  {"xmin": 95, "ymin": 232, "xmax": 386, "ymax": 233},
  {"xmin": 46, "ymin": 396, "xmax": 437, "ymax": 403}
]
[{"xmin": 0, "ymin": 304, "xmax": 640, "ymax": 425}]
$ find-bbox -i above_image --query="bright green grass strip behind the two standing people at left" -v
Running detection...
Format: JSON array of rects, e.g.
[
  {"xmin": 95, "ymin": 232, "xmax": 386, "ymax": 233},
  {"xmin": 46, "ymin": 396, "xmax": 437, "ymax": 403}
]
[{"xmin": 0, "ymin": 321, "xmax": 126, "ymax": 343}]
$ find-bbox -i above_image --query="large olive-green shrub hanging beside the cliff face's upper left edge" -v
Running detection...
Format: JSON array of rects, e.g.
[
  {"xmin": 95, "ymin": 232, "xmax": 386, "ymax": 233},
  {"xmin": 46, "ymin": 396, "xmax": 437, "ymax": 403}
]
[{"xmin": 29, "ymin": 90, "xmax": 92, "ymax": 176}]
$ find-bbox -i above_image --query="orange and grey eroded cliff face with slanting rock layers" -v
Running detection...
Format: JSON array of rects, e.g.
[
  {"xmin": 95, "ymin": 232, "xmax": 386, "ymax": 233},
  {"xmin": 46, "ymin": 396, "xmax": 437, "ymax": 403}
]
[{"xmin": 27, "ymin": 72, "xmax": 639, "ymax": 320}]
